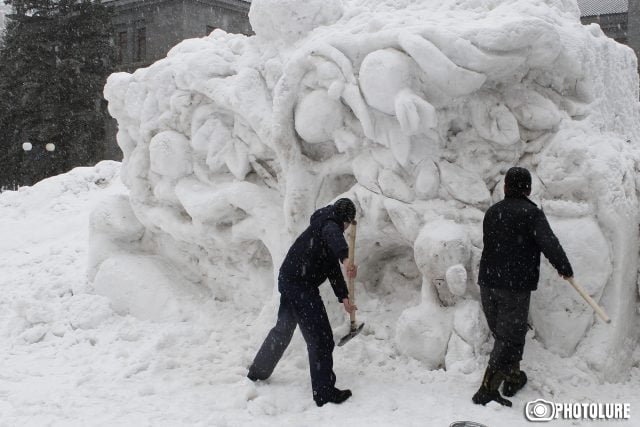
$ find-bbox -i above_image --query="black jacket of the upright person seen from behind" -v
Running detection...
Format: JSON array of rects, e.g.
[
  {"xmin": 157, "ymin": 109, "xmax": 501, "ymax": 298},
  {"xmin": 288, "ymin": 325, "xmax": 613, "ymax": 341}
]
[{"xmin": 478, "ymin": 196, "xmax": 573, "ymax": 291}]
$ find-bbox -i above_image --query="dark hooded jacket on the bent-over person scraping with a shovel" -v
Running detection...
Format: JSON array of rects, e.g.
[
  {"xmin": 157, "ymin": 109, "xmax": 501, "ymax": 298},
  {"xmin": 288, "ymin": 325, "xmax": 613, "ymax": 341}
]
[{"xmin": 278, "ymin": 205, "xmax": 349, "ymax": 301}]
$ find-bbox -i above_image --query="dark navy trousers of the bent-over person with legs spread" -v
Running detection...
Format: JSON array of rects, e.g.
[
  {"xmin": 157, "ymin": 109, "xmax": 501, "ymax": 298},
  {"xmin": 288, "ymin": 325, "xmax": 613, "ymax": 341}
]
[{"xmin": 249, "ymin": 287, "xmax": 336, "ymax": 400}]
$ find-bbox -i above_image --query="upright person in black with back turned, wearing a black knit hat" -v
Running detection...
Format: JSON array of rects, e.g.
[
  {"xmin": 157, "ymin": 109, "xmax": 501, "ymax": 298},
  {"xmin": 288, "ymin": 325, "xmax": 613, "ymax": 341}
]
[{"xmin": 473, "ymin": 167, "xmax": 573, "ymax": 406}]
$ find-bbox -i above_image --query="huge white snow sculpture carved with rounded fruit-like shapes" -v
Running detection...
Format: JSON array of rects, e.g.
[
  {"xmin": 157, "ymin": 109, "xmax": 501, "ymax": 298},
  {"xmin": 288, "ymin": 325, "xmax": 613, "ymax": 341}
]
[{"xmin": 99, "ymin": 0, "xmax": 640, "ymax": 379}]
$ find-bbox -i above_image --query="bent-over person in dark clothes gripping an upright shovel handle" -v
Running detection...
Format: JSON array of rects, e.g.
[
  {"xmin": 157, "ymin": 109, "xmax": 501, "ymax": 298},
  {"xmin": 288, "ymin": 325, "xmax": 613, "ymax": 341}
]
[{"xmin": 247, "ymin": 199, "xmax": 357, "ymax": 406}]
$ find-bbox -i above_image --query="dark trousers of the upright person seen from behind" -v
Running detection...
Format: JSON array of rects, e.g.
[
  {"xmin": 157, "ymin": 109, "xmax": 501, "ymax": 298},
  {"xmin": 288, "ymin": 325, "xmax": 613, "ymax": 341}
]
[{"xmin": 480, "ymin": 286, "xmax": 531, "ymax": 370}]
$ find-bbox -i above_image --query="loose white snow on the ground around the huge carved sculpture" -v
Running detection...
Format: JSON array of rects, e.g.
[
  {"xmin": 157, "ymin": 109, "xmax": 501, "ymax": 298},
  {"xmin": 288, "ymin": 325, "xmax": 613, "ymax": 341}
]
[{"xmin": 0, "ymin": 162, "xmax": 640, "ymax": 426}]
